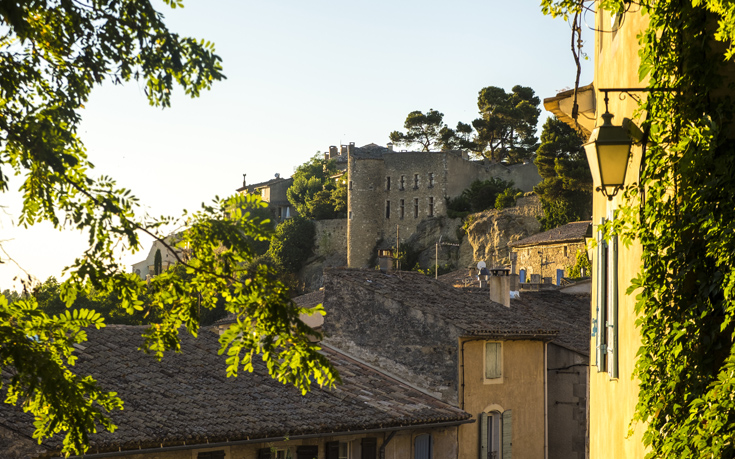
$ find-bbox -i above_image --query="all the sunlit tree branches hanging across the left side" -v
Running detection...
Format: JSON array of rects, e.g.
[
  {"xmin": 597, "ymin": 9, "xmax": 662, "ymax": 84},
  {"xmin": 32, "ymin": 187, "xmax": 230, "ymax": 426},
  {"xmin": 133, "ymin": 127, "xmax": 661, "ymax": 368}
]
[{"xmin": 0, "ymin": 0, "xmax": 337, "ymax": 453}]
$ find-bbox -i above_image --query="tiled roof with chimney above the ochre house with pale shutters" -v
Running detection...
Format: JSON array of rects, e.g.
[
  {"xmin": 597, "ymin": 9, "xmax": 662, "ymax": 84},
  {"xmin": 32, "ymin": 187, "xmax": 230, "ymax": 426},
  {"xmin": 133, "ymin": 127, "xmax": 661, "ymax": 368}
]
[{"xmin": 325, "ymin": 269, "xmax": 590, "ymax": 355}]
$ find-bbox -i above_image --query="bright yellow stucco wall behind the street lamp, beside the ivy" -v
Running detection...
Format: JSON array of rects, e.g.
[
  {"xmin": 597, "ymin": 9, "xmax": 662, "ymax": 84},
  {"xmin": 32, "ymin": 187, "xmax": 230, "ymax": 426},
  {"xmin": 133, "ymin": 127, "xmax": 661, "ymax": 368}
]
[{"xmin": 589, "ymin": 4, "xmax": 646, "ymax": 459}]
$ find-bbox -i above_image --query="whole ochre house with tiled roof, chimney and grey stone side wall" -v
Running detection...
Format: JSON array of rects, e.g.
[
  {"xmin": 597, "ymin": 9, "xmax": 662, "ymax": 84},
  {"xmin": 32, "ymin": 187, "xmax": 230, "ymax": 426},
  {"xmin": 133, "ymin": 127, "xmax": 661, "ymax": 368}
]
[{"xmin": 323, "ymin": 269, "xmax": 589, "ymax": 459}]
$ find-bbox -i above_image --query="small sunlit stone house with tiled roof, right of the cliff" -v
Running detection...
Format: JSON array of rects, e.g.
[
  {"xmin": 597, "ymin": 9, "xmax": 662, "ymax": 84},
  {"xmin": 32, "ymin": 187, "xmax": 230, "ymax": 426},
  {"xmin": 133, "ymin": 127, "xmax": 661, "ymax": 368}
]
[{"xmin": 508, "ymin": 221, "xmax": 592, "ymax": 285}]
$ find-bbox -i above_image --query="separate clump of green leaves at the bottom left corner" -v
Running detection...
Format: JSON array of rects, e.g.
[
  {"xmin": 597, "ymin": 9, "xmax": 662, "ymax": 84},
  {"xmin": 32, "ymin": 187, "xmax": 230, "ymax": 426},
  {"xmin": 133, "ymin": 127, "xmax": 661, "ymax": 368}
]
[{"xmin": 0, "ymin": 296, "xmax": 123, "ymax": 456}]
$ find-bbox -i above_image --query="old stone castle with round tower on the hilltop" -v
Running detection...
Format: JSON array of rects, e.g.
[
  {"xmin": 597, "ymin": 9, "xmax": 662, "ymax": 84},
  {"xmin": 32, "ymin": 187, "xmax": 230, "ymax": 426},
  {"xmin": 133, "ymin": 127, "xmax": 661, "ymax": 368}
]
[{"xmin": 340, "ymin": 144, "xmax": 541, "ymax": 268}]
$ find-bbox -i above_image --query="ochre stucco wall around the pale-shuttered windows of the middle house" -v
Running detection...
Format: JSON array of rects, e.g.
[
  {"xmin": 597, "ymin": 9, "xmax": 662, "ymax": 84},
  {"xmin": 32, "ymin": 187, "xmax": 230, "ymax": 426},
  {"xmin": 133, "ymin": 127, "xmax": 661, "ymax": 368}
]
[{"xmin": 460, "ymin": 339, "xmax": 545, "ymax": 459}]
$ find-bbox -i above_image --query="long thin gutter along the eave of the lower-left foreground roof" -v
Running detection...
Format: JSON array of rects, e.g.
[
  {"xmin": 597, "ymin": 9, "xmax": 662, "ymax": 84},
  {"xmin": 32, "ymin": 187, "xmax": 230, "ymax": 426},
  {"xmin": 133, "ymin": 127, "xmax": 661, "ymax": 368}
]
[{"xmin": 50, "ymin": 418, "xmax": 475, "ymax": 459}]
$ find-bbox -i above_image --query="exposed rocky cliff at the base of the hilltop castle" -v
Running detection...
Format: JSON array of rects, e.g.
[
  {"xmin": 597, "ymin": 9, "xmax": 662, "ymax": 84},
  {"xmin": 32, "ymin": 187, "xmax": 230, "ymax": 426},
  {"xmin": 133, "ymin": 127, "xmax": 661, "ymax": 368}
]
[{"xmin": 299, "ymin": 194, "xmax": 542, "ymax": 290}]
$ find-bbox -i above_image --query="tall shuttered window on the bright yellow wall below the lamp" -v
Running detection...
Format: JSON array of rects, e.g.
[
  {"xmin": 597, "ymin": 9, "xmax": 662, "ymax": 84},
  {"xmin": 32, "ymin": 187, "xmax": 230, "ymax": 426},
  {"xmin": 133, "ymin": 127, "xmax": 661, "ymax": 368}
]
[{"xmin": 592, "ymin": 218, "xmax": 618, "ymax": 378}]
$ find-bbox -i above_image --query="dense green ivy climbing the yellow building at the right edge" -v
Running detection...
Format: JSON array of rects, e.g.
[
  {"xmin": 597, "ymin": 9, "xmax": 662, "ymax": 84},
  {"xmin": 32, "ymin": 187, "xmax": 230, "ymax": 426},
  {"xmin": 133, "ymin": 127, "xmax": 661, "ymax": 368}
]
[{"xmin": 543, "ymin": 0, "xmax": 735, "ymax": 459}]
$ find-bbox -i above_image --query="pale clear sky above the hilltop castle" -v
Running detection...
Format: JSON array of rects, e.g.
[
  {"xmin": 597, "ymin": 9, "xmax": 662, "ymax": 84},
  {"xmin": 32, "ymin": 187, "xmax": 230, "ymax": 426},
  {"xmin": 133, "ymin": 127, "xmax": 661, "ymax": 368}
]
[{"xmin": 0, "ymin": 0, "xmax": 594, "ymax": 291}]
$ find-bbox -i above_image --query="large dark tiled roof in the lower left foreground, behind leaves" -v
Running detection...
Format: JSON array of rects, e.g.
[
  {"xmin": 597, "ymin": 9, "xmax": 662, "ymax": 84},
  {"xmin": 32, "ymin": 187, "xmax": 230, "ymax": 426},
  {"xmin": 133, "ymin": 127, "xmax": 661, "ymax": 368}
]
[{"xmin": 0, "ymin": 325, "xmax": 470, "ymax": 454}]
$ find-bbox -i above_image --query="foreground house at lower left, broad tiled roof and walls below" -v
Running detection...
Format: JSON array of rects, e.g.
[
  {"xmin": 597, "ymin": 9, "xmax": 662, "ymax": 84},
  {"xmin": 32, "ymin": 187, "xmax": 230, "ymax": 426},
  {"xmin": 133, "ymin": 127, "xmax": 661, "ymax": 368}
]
[{"xmin": 0, "ymin": 325, "xmax": 472, "ymax": 459}]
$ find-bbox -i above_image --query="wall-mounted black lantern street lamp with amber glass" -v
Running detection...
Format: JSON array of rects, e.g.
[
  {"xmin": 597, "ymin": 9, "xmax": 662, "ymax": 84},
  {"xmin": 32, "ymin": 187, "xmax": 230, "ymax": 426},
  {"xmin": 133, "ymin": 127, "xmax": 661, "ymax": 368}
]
[{"xmin": 584, "ymin": 101, "xmax": 633, "ymax": 201}]
